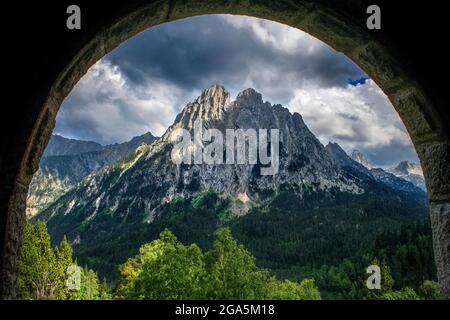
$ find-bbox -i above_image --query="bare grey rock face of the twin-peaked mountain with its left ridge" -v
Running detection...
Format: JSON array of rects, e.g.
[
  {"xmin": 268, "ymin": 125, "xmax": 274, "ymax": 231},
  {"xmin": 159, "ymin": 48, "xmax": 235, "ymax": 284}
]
[{"xmin": 40, "ymin": 85, "xmax": 362, "ymax": 224}]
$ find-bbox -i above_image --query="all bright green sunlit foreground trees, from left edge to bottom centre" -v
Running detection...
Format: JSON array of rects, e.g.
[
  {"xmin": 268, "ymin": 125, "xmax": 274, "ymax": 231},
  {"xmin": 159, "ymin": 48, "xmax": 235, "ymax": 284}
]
[{"xmin": 18, "ymin": 222, "xmax": 320, "ymax": 300}]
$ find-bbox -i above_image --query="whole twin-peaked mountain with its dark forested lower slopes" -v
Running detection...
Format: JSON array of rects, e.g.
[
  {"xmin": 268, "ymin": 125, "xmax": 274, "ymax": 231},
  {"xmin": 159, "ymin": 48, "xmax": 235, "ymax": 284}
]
[{"xmin": 33, "ymin": 85, "xmax": 426, "ymax": 273}]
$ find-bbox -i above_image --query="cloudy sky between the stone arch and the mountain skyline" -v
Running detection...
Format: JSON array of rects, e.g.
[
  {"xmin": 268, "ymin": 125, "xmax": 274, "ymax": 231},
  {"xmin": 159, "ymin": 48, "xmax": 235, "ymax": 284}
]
[{"xmin": 54, "ymin": 15, "xmax": 418, "ymax": 167}]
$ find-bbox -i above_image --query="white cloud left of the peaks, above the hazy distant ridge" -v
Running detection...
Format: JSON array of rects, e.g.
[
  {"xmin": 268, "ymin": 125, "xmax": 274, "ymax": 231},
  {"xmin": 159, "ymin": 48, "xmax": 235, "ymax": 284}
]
[{"xmin": 55, "ymin": 60, "xmax": 186, "ymax": 143}]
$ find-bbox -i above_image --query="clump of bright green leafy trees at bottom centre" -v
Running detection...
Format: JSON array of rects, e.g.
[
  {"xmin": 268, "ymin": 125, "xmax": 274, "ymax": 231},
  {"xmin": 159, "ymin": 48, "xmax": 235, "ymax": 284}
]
[{"xmin": 116, "ymin": 229, "xmax": 320, "ymax": 299}]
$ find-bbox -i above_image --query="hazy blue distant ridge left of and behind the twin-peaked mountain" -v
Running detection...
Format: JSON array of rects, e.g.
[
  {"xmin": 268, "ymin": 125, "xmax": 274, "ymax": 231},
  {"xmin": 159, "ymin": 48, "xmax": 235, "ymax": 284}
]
[{"xmin": 26, "ymin": 132, "xmax": 156, "ymax": 217}]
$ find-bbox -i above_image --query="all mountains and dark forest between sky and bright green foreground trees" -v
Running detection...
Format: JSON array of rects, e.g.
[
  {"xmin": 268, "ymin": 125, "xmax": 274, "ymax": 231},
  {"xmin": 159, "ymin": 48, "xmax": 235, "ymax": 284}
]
[{"xmin": 28, "ymin": 85, "xmax": 436, "ymax": 299}]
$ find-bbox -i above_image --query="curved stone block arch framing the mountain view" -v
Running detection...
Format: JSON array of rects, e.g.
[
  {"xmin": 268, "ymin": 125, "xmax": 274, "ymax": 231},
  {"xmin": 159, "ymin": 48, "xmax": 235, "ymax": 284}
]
[{"xmin": 2, "ymin": 1, "xmax": 449, "ymax": 298}]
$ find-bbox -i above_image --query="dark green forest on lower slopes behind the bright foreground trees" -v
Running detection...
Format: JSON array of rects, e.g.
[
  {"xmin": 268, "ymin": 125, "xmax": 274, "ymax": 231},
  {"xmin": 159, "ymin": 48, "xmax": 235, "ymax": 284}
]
[{"xmin": 46, "ymin": 186, "xmax": 436, "ymax": 299}]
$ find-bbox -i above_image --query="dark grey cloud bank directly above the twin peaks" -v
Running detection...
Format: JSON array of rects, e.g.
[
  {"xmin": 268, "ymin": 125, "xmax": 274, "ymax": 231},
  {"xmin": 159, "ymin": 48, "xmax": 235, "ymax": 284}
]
[{"xmin": 103, "ymin": 16, "xmax": 364, "ymax": 103}]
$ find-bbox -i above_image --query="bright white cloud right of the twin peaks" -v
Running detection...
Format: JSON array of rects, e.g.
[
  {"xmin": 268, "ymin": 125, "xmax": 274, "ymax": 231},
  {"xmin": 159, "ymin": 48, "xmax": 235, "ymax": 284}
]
[{"xmin": 289, "ymin": 80, "xmax": 411, "ymax": 165}]
